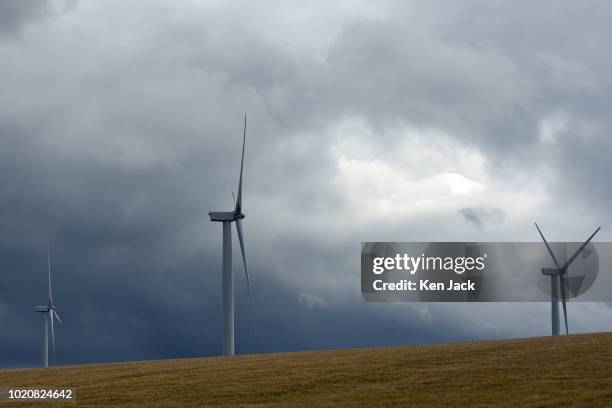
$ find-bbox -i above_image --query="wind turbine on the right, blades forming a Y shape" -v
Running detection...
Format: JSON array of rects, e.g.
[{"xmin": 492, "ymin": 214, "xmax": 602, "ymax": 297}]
[{"xmin": 535, "ymin": 223, "xmax": 601, "ymax": 336}]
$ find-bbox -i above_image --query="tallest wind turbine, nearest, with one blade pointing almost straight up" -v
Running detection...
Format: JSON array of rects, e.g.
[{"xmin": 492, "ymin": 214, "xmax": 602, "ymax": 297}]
[{"xmin": 208, "ymin": 114, "xmax": 253, "ymax": 356}]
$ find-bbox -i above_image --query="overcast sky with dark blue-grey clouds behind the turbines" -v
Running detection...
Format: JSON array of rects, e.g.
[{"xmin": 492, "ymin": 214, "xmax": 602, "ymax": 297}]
[{"xmin": 0, "ymin": 0, "xmax": 612, "ymax": 367}]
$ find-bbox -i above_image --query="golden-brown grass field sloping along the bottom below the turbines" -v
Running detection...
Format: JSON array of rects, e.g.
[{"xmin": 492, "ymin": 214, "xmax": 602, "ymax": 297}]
[{"xmin": 0, "ymin": 333, "xmax": 612, "ymax": 408}]
